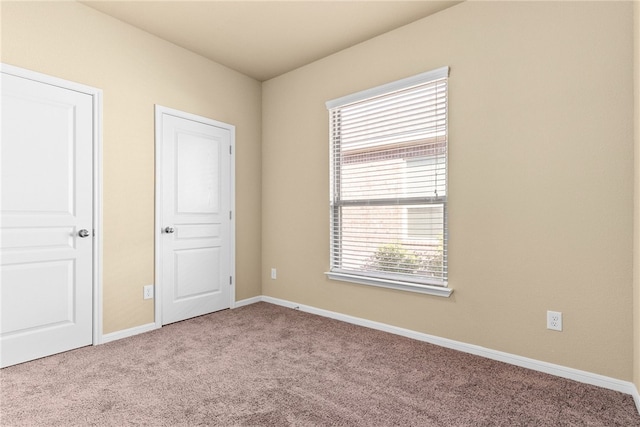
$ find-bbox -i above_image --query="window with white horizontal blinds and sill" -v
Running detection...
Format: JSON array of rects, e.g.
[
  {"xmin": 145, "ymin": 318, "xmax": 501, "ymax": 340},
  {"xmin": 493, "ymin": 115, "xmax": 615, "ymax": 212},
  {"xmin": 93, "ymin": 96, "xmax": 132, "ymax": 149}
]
[{"xmin": 327, "ymin": 67, "xmax": 451, "ymax": 296}]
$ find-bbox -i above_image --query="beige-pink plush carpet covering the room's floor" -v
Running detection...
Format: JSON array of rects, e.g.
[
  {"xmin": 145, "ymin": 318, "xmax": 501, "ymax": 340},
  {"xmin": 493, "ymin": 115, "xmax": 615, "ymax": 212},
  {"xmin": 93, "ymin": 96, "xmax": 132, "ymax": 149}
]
[{"xmin": 0, "ymin": 303, "xmax": 640, "ymax": 426}]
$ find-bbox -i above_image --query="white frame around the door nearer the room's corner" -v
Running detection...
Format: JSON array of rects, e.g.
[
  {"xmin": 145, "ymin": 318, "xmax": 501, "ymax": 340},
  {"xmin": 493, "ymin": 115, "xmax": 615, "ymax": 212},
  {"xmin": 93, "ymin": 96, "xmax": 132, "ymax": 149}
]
[{"xmin": 153, "ymin": 104, "xmax": 236, "ymax": 328}]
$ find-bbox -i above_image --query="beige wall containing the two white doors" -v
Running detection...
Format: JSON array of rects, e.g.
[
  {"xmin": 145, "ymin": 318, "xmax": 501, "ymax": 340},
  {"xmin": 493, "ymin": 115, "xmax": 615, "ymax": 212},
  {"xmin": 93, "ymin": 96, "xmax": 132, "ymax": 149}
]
[{"xmin": 2, "ymin": 2, "xmax": 261, "ymax": 333}]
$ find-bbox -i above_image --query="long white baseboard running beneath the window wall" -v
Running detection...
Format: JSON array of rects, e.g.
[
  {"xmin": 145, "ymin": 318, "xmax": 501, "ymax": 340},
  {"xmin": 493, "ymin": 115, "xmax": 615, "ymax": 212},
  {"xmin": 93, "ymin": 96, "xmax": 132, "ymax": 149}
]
[{"xmin": 254, "ymin": 296, "xmax": 640, "ymax": 413}]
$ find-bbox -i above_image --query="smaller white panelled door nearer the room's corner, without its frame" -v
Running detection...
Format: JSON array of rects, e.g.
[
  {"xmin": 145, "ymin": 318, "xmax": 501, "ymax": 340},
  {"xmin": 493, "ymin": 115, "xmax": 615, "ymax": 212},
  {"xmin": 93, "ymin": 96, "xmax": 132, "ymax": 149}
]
[{"xmin": 156, "ymin": 106, "xmax": 234, "ymax": 324}]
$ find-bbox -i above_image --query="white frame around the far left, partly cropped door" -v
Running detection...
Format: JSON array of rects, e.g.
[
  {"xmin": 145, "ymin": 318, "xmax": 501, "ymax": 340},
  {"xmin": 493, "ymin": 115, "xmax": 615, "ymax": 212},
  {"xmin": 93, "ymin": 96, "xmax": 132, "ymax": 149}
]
[{"xmin": 0, "ymin": 63, "xmax": 103, "ymax": 346}]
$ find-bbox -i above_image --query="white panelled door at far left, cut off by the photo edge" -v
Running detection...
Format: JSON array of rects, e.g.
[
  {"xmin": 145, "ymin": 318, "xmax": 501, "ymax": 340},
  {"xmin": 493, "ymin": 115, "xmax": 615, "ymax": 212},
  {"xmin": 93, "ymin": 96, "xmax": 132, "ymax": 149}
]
[{"xmin": 0, "ymin": 67, "xmax": 94, "ymax": 367}]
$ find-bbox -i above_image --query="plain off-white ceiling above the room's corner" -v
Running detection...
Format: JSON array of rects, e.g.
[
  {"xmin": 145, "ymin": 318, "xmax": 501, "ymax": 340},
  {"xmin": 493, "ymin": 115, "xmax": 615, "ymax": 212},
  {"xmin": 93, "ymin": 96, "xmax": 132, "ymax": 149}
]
[{"xmin": 81, "ymin": 0, "xmax": 460, "ymax": 81}]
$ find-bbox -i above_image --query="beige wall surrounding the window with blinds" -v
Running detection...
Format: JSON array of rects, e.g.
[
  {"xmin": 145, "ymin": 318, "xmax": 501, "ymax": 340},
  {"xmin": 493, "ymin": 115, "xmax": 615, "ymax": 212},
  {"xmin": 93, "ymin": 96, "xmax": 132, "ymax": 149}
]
[{"xmin": 262, "ymin": 2, "xmax": 633, "ymax": 380}]
